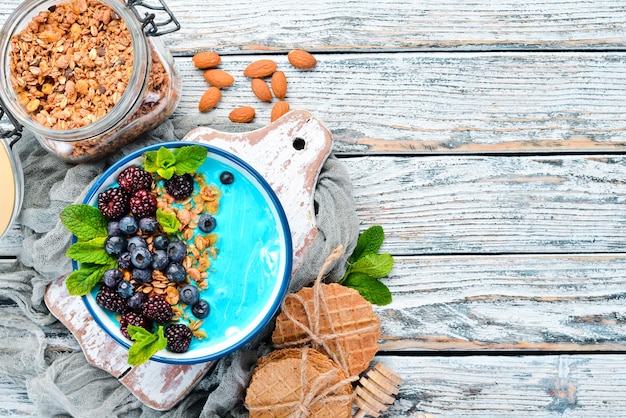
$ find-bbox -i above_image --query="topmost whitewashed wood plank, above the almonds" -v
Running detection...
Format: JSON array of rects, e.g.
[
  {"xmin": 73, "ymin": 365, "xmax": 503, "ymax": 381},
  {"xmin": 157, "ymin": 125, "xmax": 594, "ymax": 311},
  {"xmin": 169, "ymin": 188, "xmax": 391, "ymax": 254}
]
[{"xmin": 0, "ymin": 0, "xmax": 626, "ymax": 53}]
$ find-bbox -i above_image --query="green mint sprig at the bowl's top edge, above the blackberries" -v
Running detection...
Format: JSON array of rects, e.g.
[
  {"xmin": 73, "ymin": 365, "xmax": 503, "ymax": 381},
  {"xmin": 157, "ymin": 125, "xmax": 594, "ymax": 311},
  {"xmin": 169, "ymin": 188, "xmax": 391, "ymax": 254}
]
[{"xmin": 143, "ymin": 145, "xmax": 208, "ymax": 180}]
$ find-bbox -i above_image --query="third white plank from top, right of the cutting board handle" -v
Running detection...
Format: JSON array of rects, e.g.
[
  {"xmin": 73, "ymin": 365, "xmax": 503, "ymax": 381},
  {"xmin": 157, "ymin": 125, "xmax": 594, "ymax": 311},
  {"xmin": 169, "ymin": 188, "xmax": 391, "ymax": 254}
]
[{"xmin": 342, "ymin": 155, "xmax": 626, "ymax": 255}]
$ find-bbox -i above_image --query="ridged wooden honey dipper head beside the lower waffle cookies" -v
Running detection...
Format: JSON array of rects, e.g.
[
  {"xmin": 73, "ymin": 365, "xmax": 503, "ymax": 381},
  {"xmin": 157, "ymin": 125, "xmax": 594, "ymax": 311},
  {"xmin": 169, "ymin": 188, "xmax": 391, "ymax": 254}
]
[{"xmin": 354, "ymin": 363, "xmax": 402, "ymax": 418}]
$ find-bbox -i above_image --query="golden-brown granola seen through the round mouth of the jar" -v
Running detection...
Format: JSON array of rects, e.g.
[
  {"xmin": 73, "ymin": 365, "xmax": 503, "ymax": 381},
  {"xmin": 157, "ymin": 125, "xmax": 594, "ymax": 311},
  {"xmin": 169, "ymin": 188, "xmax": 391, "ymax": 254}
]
[{"xmin": 10, "ymin": 0, "xmax": 133, "ymax": 130}]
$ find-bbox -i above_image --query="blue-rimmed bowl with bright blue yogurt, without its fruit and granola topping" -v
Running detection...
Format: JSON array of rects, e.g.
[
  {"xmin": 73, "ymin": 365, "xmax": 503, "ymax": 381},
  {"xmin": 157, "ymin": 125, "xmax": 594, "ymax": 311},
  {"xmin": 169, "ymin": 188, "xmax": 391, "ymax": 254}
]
[{"xmin": 74, "ymin": 142, "xmax": 292, "ymax": 364}]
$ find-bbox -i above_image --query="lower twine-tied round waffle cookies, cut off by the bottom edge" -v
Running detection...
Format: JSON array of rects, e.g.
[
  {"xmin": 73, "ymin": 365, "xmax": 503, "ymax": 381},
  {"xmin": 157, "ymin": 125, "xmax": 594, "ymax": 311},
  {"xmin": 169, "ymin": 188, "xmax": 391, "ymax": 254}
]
[{"xmin": 245, "ymin": 347, "xmax": 354, "ymax": 418}]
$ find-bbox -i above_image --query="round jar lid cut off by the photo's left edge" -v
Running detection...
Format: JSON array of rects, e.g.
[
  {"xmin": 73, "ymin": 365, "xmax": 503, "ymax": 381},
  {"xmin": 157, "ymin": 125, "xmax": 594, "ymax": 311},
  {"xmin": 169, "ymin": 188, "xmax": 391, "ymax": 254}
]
[{"xmin": 0, "ymin": 139, "xmax": 23, "ymax": 237}]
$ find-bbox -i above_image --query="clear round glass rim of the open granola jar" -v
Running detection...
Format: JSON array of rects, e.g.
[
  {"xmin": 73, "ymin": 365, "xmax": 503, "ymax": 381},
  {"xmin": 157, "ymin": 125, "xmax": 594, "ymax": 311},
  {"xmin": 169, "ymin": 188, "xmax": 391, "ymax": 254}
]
[{"xmin": 0, "ymin": 0, "xmax": 151, "ymax": 142}]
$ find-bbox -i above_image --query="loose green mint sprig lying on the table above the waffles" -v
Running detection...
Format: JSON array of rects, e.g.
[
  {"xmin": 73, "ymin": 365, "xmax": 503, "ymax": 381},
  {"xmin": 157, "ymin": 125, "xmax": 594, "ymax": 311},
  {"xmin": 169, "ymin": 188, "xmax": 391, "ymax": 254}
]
[{"xmin": 339, "ymin": 225, "xmax": 393, "ymax": 306}]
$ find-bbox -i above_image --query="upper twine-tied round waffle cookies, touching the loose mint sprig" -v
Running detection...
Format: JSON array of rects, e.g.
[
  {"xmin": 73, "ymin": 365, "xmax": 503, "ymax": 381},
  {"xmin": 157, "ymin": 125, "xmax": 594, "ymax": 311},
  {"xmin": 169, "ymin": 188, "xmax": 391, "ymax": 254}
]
[{"xmin": 272, "ymin": 283, "xmax": 380, "ymax": 376}]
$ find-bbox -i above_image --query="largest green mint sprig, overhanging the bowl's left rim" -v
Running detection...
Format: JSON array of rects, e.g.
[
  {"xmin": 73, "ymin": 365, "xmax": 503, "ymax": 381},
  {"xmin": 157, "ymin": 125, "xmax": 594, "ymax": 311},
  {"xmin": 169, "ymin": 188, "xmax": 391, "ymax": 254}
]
[{"xmin": 61, "ymin": 204, "xmax": 117, "ymax": 296}]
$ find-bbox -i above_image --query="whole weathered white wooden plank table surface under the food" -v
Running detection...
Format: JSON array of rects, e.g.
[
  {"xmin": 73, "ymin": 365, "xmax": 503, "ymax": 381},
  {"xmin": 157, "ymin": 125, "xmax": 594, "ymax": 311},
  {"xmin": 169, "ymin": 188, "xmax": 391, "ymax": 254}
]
[{"xmin": 0, "ymin": 0, "xmax": 626, "ymax": 417}]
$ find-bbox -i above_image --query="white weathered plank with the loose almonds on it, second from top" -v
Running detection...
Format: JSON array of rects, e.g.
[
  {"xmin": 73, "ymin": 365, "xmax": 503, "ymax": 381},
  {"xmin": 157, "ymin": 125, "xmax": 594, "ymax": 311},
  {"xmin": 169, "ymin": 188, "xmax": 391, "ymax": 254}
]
[{"xmin": 167, "ymin": 53, "xmax": 626, "ymax": 155}]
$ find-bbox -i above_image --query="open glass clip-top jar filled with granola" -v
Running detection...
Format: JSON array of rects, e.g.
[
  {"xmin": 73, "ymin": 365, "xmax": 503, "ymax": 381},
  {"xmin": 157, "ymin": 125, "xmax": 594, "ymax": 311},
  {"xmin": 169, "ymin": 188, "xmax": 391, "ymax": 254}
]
[{"xmin": 0, "ymin": 0, "xmax": 181, "ymax": 163}]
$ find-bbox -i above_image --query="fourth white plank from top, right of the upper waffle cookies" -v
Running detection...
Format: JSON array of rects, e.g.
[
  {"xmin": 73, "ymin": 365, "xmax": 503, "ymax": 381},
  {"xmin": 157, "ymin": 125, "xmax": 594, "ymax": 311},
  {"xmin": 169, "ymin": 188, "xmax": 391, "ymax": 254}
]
[{"xmin": 376, "ymin": 254, "xmax": 626, "ymax": 352}]
